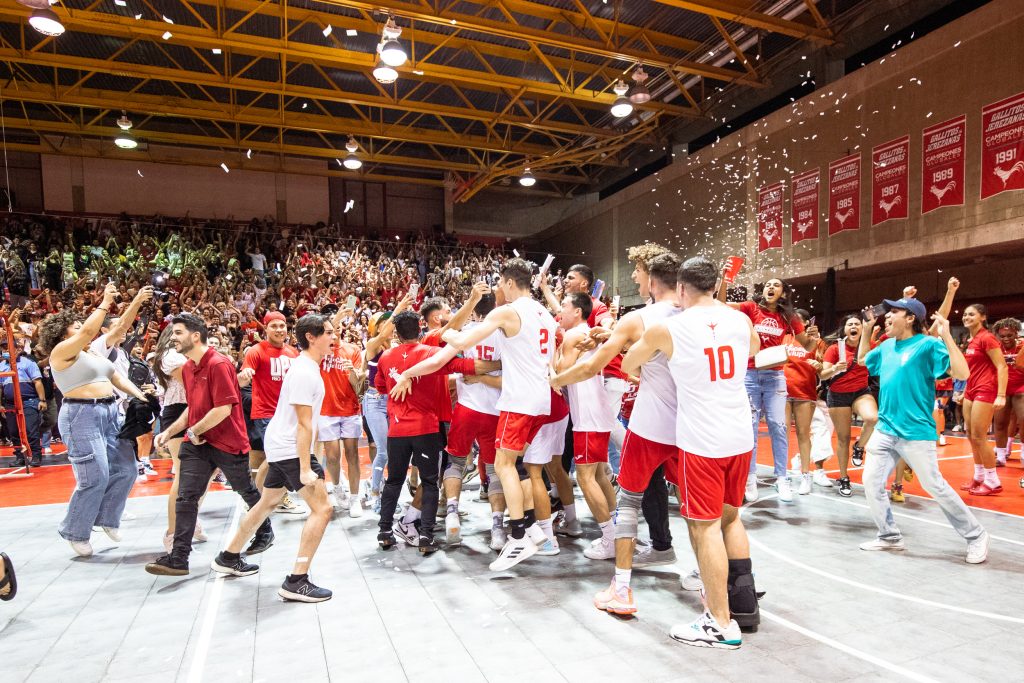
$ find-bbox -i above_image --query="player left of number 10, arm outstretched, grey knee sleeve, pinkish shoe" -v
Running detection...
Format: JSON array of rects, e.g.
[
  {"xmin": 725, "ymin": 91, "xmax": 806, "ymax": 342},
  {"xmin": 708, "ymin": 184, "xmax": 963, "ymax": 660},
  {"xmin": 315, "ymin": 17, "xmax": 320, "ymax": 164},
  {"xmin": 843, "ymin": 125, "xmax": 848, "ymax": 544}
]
[{"xmin": 551, "ymin": 248, "xmax": 681, "ymax": 614}]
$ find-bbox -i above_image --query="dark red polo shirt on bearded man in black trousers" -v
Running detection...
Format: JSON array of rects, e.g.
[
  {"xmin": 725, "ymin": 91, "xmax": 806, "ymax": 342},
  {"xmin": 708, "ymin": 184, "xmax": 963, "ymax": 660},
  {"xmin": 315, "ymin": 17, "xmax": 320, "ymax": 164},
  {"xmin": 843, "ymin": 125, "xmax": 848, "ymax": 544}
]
[{"xmin": 181, "ymin": 348, "xmax": 249, "ymax": 456}]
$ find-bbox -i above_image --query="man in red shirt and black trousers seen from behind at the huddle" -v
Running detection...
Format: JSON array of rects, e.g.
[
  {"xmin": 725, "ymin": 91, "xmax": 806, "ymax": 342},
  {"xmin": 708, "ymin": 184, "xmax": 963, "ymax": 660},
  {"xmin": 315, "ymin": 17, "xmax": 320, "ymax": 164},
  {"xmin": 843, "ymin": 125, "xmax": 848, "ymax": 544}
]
[{"xmin": 374, "ymin": 311, "xmax": 500, "ymax": 554}]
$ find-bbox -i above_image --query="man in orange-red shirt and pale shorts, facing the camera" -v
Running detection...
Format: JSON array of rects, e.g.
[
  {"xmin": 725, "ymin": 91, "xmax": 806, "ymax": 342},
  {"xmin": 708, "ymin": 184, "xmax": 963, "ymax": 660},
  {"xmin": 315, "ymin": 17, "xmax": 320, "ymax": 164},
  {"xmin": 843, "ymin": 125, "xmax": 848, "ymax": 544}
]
[{"xmin": 317, "ymin": 308, "xmax": 362, "ymax": 517}]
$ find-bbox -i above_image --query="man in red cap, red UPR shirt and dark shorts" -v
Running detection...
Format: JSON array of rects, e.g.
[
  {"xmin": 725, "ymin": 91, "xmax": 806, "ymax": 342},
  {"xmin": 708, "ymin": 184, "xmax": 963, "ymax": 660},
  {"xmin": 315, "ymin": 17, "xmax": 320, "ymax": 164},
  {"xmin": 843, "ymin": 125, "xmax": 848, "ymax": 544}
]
[{"xmin": 239, "ymin": 311, "xmax": 305, "ymax": 501}]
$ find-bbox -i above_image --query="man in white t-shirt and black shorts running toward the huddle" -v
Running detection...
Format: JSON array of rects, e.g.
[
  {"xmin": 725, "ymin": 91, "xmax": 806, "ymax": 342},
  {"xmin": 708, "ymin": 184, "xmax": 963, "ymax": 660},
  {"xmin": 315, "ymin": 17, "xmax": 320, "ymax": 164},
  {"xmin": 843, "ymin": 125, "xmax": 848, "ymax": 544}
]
[{"xmin": 211, "ymin": 314, "xmax": 334, "ymax": 602}]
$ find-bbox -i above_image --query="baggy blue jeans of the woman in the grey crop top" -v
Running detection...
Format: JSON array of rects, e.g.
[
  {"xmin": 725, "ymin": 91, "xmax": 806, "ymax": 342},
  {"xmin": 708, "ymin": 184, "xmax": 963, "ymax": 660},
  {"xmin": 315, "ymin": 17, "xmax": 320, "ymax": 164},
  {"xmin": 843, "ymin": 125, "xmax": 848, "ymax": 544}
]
[{"xmin": 57, "ymin": 401, "xmax": 138, "ymax": 541}]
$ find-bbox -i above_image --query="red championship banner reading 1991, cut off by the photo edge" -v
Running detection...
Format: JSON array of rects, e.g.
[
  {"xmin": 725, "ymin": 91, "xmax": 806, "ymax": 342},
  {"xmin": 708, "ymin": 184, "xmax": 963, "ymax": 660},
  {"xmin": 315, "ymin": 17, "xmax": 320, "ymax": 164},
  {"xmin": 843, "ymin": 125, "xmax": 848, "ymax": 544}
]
[{"xmin": 981, "ymin": 92, "xmax": 1024, "ymax": 200}]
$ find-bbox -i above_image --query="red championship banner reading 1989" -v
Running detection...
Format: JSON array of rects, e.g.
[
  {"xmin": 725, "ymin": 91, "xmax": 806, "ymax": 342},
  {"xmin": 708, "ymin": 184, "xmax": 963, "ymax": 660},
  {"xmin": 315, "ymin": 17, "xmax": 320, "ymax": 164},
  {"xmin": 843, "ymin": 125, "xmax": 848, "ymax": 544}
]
[{"xmin": 921, "ymin": 114, "xmax": 967, "ymax": 214}]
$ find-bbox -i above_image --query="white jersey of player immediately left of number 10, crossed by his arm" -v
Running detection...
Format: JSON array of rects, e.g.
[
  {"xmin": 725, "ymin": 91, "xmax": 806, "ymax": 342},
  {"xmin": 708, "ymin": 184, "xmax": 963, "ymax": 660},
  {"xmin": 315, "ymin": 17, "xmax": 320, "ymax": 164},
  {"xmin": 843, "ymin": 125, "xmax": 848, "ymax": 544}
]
[{"xmin": 630, "ymin": 301, "xmax": 683, "ymax": 445}]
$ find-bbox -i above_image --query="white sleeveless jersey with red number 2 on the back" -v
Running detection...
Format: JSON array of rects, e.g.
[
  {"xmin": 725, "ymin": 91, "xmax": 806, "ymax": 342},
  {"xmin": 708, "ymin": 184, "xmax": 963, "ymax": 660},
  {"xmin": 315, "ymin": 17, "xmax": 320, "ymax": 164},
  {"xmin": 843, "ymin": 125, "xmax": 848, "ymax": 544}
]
[{"xmin": 498, "ymin": 297, "xmax": 555, "ymax": 415}]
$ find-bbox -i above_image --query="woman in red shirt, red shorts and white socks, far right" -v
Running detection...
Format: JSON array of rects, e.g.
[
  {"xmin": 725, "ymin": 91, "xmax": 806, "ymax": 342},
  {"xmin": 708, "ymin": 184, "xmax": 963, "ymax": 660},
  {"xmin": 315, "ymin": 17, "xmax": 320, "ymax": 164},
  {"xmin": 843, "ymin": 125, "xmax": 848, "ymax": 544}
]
[{"xmin": 961, "ymin": 303, "xmax": 1007, "ymax": 496}]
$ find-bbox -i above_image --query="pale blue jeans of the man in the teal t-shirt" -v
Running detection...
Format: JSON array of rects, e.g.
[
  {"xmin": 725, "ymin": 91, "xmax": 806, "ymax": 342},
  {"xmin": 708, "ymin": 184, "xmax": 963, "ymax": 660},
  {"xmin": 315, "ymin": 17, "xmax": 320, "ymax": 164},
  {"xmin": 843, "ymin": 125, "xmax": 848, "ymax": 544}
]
[{"xmin": 864, "ymin": 436, "xmax": 985, "ymax": 542}]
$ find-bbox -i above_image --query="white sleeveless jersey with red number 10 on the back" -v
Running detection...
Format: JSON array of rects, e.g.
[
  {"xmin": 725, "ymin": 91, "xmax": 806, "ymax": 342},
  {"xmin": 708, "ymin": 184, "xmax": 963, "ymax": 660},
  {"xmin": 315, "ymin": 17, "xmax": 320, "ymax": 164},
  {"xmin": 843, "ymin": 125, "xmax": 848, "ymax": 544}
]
[{"xmin": 667, "ymin": 303, "xmax": 754, "ymax": 458}]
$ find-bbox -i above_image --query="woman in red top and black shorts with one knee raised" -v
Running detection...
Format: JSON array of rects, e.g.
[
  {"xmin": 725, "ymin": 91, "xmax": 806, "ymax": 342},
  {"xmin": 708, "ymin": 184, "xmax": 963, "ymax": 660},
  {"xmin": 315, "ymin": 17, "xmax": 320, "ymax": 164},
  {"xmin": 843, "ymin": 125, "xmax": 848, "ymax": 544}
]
[{"xmin": 821, "ymin": 315, "xmax": 879, "ymax": 497}]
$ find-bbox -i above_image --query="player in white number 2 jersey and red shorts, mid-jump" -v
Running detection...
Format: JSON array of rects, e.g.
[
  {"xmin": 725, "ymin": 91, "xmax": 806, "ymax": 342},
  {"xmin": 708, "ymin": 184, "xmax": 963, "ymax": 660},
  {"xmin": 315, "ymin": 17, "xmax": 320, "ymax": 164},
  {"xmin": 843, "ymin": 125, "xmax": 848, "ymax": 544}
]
[{"xmin": 434, "ymin": 258, "xmax": 555, "ymax": 571}]
